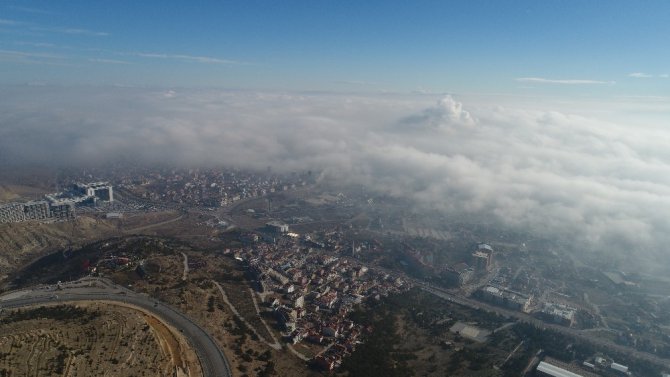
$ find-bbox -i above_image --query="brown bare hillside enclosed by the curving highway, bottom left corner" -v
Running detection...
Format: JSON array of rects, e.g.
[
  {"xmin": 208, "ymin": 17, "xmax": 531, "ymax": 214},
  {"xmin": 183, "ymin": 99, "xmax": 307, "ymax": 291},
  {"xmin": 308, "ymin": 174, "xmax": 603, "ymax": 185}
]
[{"xmin": 0, "ymin": 303, "xmax": 202, "ymax": 377}]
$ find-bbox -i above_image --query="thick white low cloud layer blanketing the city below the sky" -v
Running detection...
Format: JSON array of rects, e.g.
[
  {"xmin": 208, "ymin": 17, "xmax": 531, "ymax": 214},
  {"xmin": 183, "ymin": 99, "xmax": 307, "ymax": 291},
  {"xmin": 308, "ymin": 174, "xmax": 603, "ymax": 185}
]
[{"xmin": 0, "ymin": 87, "xmax": 670, "ymax": 267}]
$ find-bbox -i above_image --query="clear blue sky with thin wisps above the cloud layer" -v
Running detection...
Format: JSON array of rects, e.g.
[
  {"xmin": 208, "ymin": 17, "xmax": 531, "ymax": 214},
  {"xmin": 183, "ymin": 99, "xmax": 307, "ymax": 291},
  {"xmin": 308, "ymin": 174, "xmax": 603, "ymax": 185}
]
[{"xmin": 0, "ymin": 0, "xmax": 670, "ymax": 97}]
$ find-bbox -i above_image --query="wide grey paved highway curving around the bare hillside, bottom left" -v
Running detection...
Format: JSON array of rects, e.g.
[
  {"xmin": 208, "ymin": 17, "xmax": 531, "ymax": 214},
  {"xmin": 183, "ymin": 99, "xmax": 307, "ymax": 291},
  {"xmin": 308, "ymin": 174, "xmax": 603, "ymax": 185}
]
[{"xmin": 0, "ymin": 286, "xmax": 232, "ymax": 377}]
